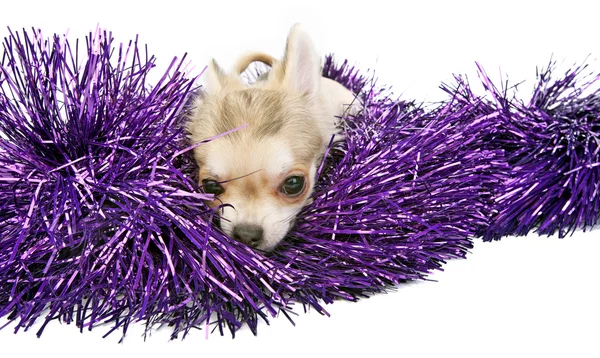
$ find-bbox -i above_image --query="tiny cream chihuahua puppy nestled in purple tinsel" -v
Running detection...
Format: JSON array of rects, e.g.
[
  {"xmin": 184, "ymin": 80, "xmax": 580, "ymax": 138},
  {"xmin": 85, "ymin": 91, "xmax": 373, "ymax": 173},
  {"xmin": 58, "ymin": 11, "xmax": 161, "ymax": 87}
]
[{"xmin": 187, "ymin": 24, "xmax": 358, "ymax": 251}]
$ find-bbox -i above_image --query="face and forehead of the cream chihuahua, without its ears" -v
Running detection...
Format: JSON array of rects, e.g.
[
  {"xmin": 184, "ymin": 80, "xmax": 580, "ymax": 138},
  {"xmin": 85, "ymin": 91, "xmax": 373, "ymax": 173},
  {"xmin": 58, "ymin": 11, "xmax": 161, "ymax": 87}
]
[{"xmin": 194, "ymin": 89, "xmax": 322, "ymax": 251}]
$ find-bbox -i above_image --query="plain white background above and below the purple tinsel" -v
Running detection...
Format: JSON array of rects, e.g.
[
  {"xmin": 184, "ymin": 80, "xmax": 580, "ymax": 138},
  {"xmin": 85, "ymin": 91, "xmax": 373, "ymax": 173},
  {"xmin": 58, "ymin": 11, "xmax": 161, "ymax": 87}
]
[{"xmin": 0, "ymin": 0, "xmax": 600, "ymax": 357}]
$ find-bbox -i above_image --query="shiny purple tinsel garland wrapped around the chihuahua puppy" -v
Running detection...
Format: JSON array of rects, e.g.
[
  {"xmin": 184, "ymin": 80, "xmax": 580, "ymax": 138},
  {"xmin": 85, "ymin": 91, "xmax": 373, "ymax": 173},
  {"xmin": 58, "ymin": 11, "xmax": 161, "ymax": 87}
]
[{"xmin": 0, "ymin": 28, "xmax": 600, "ymax": 337}]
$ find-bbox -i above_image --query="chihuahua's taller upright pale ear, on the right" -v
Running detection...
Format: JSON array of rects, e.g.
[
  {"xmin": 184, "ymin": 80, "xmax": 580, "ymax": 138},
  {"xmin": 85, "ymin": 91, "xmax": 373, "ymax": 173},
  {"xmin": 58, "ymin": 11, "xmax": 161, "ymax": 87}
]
[{"xmin": 281, "ymin": 24, "xmax": 321, "ymax": 95}]
